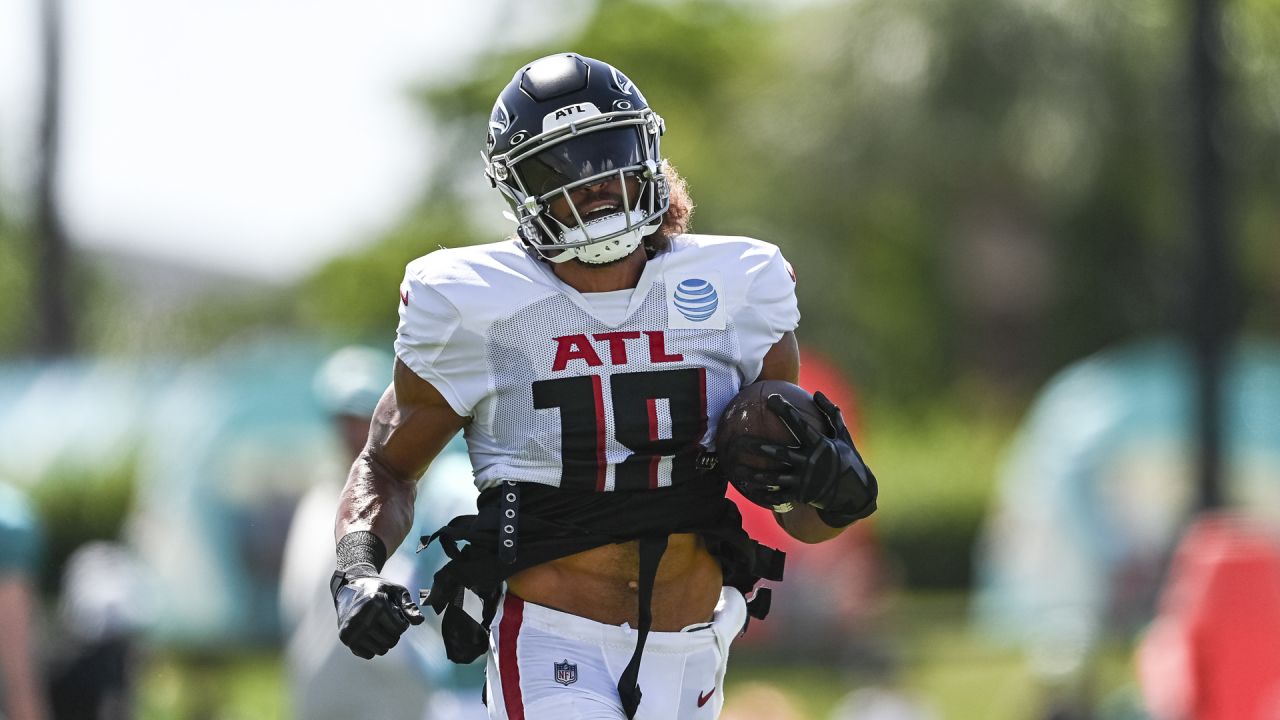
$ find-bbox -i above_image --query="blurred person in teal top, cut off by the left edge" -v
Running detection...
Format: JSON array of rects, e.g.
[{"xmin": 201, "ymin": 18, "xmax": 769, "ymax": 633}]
[{"xmin": 0, "ymin": 483, "xmax": 49, "ymax": 720}]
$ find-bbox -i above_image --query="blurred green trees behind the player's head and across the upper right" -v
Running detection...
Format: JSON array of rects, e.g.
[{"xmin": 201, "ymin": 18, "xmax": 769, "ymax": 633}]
[{"xmin": 296, "ymin": 0, "xmax": 1280, "ymax": 415}]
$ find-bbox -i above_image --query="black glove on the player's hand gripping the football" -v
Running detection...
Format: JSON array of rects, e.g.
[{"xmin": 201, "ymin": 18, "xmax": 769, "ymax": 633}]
[{"xmin": 755, "ymin": 392, "xmax": 879, "ymax": 527}]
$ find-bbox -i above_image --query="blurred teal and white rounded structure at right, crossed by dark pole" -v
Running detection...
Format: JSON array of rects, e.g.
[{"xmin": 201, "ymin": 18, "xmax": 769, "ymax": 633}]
[{"xmin": 974, "ymin": 340, "xmax": 1280, "ymax": 717}]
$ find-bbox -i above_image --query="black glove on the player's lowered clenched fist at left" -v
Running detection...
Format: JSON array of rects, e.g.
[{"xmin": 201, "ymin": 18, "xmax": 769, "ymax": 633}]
[{"xmin": 329, "ymin": 562, "xmax": 424, "ymax": 660}]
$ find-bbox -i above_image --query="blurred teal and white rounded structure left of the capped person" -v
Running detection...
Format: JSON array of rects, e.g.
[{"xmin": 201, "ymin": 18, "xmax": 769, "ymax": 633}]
[{"xmin": 128, "ymin": 340, "xmax": 332, "ymax": 647}]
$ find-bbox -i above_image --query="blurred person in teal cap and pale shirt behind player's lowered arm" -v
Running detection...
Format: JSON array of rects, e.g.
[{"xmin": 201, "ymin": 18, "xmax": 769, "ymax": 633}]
[{"xmin": 280, "ymin": 346, "xmax": 485, "ymax": 720}]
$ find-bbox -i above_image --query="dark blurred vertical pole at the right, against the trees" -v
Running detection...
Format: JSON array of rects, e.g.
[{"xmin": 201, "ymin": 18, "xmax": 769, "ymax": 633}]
[{"xmin": 1189, "ymin": 0, "xmax": 1234, "ymax": 510}]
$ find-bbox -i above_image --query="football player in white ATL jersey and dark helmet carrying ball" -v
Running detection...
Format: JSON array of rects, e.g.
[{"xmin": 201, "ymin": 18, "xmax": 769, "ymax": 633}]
[{"xmin": 332, "ymin": 54, "xmax": 876, "ymax": 720}]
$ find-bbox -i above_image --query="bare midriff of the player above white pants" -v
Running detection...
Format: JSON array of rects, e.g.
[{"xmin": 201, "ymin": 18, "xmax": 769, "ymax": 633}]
[{"xmin": 507, "ymin": 533, "xmax": 722, "ymax": 632}]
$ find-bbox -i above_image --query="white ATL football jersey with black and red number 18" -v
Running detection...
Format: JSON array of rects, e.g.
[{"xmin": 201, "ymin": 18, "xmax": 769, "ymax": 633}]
[{"xmin": 396, "ymin": 234, "xmax": 800, "ymax": 491}]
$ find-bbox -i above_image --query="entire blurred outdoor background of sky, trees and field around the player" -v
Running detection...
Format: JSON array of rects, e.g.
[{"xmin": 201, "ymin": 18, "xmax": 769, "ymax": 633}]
[{"xmin": 0, "ymin": 0, "xmax": 1280, "ymax": 720}]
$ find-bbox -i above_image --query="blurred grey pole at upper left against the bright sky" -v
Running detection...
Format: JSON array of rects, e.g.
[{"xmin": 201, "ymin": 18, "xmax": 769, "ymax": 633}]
[{"xmin": 32, "ymin": 0, "xmax": 74, "ymax": 357}]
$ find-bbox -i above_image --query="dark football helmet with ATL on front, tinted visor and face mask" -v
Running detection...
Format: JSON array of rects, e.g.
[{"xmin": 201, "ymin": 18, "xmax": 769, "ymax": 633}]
[{"xmin": 484, "ymin": 54, "xmax": 669, "ymax": 264}]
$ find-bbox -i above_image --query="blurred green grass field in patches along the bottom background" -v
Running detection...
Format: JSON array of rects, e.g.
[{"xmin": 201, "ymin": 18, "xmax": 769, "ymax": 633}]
[{"xmin": 137, "ymin": 593, "xmax": 1140, "ymax": 720}]
